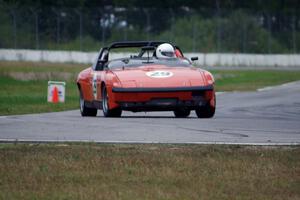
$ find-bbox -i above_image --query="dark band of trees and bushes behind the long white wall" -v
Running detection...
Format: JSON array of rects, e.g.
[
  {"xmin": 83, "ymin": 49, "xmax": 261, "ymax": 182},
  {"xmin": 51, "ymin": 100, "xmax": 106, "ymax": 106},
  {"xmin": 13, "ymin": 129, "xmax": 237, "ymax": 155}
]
[{"xmin": 0, "ymin": 4, "xmax": 300, "ymax": 53}]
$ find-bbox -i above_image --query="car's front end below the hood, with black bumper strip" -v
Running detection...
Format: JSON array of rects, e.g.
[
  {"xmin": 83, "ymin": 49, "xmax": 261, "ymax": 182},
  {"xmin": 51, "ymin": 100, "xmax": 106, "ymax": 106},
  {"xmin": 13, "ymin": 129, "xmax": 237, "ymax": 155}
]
[{"xmin": 112, "ymin": 85, "xmax": 214, "ymax": 112}]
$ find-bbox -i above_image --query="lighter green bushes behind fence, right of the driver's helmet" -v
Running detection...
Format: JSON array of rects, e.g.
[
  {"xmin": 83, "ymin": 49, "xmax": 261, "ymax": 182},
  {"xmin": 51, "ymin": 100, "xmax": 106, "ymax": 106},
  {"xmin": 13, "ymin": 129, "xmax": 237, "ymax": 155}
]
[{"xmin": 158, "ymin": 10, "xmax": 288, "ymax": 53}]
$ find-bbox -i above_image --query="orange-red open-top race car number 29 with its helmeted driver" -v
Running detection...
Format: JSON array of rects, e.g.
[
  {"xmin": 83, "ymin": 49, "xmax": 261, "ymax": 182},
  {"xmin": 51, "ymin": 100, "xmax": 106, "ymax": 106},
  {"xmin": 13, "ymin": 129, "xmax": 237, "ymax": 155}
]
[{"xmin": 77, "ymin": 41, "xmax": 216, "ymax": 118}]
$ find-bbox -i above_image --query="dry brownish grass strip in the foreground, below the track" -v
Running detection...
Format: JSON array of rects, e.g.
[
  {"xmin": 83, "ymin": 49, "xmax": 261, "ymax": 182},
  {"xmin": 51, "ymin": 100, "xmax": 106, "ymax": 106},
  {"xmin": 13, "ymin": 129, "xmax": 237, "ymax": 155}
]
[{"xmin": 0, "ymin": 144, "xmax": 300, "ymax": 200}]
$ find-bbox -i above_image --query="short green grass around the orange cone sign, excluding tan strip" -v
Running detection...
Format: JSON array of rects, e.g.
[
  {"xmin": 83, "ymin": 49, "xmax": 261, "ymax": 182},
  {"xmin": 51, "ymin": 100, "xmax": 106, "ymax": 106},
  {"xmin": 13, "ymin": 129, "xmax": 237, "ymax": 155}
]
[{"xmin": 0, "ymin": 77, "xmax": 78, "ymax": 114}]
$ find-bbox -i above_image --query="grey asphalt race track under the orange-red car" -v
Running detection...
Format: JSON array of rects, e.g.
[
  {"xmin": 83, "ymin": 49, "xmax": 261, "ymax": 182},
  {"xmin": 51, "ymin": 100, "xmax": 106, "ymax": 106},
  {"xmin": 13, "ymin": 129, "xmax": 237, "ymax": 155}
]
[{"xmin": 0, "ymin": 81, "xmax": 300, "ymax": 145}]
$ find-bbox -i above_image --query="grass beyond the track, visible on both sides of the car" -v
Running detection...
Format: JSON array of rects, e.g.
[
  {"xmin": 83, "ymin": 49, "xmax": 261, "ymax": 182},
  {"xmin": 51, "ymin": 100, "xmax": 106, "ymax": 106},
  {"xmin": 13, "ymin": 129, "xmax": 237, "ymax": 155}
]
[{"xmin": 0, "ymin": 61, "xmax": 300, "ymax": 115}]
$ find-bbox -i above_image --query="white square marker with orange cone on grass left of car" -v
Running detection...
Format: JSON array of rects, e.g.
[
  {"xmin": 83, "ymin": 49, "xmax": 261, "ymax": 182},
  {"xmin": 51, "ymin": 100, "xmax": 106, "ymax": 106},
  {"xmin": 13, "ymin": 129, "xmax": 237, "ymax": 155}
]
[{"xmin": 48, "ymin": 81, "xmax": 66, "ymax": 103}]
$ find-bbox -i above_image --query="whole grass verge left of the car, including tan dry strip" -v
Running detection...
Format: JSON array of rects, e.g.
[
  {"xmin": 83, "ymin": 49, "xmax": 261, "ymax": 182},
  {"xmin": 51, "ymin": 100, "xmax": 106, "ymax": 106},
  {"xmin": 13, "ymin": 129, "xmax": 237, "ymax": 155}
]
[{"xmin": 0, "ymin": 62, "xmax": 88, "ymax": 115}]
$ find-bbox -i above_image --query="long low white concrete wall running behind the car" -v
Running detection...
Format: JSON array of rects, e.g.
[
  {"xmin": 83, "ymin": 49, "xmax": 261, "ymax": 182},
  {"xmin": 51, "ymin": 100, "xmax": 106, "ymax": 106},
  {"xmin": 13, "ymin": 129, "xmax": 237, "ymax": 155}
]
[{"xmin": 0, "ymin": 49, "xmax": 300, "ymax": 68}]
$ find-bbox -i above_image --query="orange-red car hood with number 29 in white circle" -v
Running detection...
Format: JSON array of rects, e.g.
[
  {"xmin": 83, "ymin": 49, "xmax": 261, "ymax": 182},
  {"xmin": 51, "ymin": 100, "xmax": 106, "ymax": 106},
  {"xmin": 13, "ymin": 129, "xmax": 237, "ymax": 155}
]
[{"xmin": 113, "ymin": 65, "xmax": 207, "ymax": 88}]
